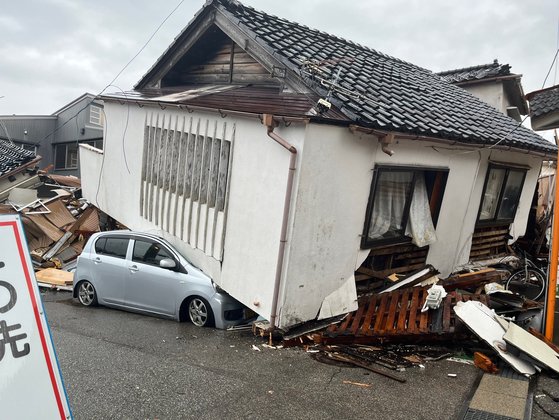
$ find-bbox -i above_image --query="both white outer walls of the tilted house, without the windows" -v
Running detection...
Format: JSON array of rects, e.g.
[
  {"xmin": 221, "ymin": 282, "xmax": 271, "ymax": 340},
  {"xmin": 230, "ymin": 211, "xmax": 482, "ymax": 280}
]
[{"xmin": 80, "ymin": 102, "xmax": 541, "ymax": 327}]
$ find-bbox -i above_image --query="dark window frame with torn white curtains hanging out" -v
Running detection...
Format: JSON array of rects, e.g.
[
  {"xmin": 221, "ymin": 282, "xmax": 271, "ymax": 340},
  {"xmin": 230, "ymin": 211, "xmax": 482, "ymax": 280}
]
[{"xmin": 361, "ymin": 165, "xmax": 449, "ymax": 249}]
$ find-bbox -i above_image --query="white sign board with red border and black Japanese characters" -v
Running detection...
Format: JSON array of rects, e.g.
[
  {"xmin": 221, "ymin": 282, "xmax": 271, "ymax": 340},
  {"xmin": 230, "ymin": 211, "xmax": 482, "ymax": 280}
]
[{"xmin": 0, "ymin": 215, "xmax": 72, "ymax": 419}]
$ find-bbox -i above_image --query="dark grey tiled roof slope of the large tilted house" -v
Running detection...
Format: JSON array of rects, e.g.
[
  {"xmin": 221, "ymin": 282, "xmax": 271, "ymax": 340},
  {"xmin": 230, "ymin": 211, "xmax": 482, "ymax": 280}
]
[{"xmin": 213, "ymin": 0, "xmax": 556, "ymax": 153}]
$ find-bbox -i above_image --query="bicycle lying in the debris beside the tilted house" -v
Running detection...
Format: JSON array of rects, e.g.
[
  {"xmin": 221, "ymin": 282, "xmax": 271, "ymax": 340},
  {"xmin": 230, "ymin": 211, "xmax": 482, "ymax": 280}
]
[{"xmin": 505, "ymin": 250, "xmax": 547, "ymax": 300}]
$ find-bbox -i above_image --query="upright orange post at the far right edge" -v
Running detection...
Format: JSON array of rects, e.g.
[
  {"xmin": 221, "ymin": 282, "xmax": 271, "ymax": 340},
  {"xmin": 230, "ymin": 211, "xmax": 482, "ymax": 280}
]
[{"xmin": 545, "ymin": 162, "xmax": 559, "ymax": 341}]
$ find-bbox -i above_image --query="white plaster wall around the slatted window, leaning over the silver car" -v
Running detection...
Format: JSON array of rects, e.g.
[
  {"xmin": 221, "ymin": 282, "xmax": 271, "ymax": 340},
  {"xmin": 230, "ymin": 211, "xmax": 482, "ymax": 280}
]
[{"xmin": 80, "ymin": 102, "xmax": 305, "ymax": 319}]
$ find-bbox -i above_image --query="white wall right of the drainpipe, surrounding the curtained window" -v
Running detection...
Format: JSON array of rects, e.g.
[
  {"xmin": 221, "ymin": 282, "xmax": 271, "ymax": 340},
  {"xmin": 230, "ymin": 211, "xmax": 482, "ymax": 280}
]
[{"xmin": 280, "ymin": 125, "xmax": 541, "ymax": 326}]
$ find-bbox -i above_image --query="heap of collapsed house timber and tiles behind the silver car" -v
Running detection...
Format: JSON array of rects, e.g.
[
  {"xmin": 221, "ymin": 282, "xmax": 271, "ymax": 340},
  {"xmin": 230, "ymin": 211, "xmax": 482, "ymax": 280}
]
[{"xmin": 0, "ymin": 141, "xmax": 100, "ymax": 278}]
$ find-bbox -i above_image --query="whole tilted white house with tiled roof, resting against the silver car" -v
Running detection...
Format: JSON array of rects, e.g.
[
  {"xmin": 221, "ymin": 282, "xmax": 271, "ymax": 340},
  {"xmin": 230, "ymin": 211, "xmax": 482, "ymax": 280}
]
[{"xmin": 80, "ymin": 0, "xmax": 556, "ymax": 329}]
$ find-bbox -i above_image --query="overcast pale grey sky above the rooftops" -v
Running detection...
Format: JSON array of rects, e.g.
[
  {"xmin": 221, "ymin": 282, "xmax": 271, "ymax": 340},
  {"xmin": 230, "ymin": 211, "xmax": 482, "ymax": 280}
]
[{"xmin": 0, "ymin": 0, "xmax": 559, "ymax": 119}]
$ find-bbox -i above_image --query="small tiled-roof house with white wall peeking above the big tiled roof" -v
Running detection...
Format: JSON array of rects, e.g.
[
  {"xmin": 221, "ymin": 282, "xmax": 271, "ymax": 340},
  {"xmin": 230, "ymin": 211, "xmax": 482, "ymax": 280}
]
[{"xmin": 437, "ymin": 60, "xmax": 528, "ymax": 121}]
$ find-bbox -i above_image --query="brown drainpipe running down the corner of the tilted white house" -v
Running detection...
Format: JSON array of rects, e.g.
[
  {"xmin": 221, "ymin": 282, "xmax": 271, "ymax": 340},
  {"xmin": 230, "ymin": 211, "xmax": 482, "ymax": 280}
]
[{"xmin": 263, "ymin": 114, "xmax": 297, "ymax": 329}]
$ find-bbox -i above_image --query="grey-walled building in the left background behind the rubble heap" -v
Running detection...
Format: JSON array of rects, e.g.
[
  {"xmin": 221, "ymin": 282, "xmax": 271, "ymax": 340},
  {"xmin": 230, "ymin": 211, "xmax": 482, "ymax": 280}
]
[{"xmin": 0, "ymin": 93, "xmax": 104, "ymax": 176}]
